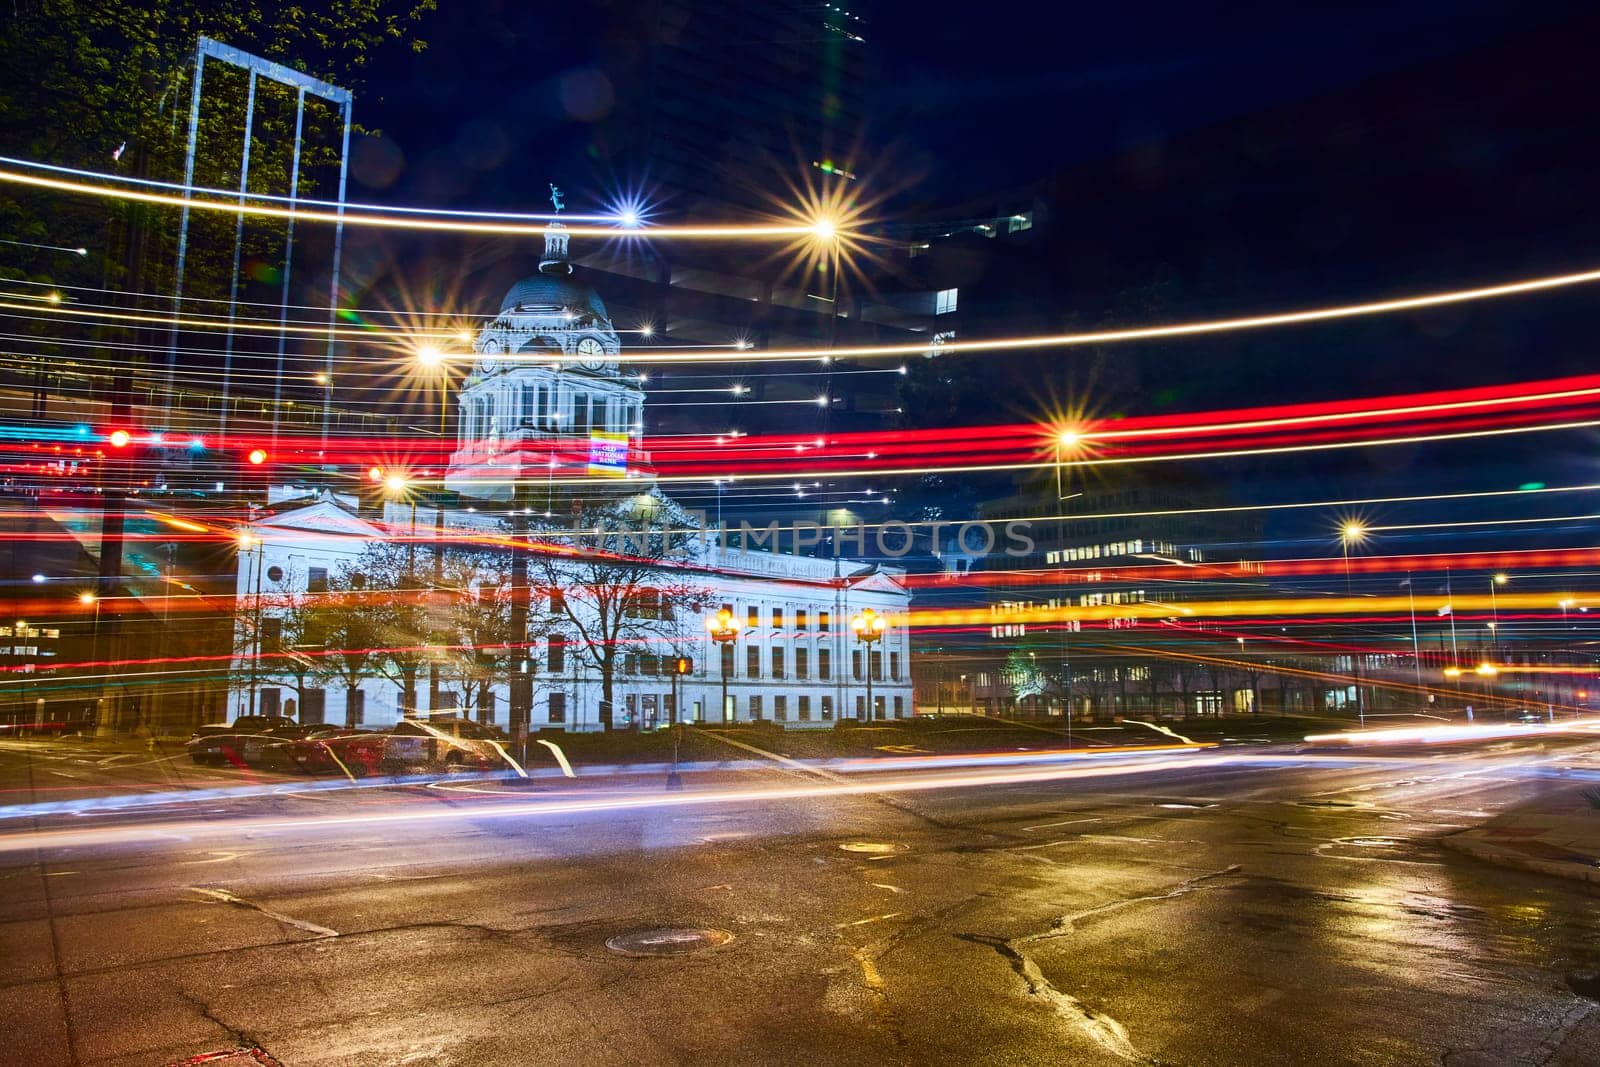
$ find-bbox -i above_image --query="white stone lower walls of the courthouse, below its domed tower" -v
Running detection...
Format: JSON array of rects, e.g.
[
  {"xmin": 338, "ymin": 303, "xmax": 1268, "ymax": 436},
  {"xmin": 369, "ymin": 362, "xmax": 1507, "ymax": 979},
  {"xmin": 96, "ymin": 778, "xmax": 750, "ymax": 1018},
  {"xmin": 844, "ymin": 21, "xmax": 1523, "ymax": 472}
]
[{"xmin": 229, "ymin": 494, "xmax": 914, "ymax": 731}]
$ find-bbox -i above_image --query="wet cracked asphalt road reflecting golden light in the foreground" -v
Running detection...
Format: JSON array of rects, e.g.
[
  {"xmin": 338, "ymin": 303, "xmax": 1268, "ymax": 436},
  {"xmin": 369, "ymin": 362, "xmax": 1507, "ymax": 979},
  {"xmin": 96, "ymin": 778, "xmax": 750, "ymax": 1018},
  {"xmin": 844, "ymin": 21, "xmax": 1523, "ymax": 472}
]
[{"xmin": 0, "ymin": 742, "xmax": 1600, "ymax": 1065}]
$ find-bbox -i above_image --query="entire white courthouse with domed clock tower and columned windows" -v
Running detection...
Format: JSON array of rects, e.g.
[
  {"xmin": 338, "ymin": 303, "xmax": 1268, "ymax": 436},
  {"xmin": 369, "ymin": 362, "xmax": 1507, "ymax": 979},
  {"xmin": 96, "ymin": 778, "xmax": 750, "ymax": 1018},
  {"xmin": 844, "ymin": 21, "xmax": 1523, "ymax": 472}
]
[{"xmin": 229, "ymin": 224, "xmax": 914, "ymax": 729}]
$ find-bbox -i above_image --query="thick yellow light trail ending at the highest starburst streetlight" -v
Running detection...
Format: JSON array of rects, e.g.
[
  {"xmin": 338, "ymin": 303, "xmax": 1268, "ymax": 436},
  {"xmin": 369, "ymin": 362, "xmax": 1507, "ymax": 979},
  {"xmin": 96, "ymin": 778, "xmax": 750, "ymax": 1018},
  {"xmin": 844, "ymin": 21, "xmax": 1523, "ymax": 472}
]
[{"xmin": 0, "ymin": 170, "xmax": 818, "ymax": 240}]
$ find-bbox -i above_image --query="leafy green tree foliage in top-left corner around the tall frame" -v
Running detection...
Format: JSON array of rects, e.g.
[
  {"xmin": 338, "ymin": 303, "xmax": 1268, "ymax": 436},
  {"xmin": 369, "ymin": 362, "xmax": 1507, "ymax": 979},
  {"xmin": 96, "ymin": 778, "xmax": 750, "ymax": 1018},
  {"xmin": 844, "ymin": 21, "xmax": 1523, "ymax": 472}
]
[{"xmin": 0, "ymin": 0, "xmax": 435, "ymax": 299}]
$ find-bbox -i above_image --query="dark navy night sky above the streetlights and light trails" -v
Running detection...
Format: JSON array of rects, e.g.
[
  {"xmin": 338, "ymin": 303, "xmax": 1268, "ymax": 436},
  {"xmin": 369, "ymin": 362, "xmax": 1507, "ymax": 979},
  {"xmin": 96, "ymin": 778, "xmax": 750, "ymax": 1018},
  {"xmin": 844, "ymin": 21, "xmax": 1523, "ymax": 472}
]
[{"xmin": 352, "ymin": 0, "xmax": 1600, "ymax": 559}]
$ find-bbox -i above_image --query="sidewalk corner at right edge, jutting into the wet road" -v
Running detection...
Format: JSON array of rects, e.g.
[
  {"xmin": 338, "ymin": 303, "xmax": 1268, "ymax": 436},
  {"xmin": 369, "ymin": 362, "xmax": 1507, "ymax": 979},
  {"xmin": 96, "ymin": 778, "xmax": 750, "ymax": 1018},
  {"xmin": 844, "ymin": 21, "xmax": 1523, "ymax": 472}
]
[{"xmin": 1440, "ymin": 789, "xmax": 1600, "ymax": 885}]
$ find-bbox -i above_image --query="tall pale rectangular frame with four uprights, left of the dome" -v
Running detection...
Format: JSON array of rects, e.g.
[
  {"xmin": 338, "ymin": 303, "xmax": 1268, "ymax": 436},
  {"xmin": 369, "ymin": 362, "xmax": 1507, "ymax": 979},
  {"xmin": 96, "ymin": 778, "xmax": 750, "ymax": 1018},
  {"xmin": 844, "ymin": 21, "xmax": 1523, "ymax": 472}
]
[{"xmin": 166, "ymin": 37, "xmax": 355, "ymax": 451}]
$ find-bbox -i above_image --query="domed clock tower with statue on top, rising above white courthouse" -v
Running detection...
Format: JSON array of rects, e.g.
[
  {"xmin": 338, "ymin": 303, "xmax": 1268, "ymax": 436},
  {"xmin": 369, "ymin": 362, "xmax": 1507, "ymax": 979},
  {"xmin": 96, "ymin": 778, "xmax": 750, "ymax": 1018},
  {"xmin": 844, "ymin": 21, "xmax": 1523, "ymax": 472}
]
[{"xmin": 445, "ymin": 221, "xmax": 648, "ymax": 501}]
